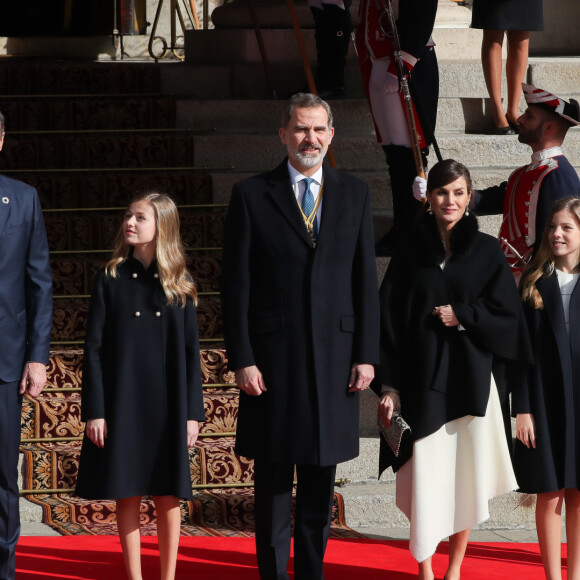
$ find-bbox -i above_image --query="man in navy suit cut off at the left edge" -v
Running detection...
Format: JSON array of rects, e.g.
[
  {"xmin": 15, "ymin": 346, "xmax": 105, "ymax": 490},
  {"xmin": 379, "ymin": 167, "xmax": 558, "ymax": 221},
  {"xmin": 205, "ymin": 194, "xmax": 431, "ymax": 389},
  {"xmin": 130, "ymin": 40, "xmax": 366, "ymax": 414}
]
[{"xmin": 0, "ymin": 113, "xmax": 52, "ymax": 580}]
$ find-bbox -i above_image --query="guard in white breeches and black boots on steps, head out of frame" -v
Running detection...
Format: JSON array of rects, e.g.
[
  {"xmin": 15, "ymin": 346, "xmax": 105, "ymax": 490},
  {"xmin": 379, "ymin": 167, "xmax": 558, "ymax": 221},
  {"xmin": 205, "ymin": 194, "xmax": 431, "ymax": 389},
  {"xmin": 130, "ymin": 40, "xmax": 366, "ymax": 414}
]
[{"xmin": 355, "ymin": 0, "xmax": 439, "ymax": 256}]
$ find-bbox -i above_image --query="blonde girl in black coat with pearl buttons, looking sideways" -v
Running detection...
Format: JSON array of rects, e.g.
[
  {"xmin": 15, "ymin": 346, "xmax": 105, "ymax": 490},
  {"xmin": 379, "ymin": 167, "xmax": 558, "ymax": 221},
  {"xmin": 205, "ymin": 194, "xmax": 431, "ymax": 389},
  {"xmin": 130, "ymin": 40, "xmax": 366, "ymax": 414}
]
[{"xmin": 77, "ymin": 193, "xmax": 204, "ymax": 580}]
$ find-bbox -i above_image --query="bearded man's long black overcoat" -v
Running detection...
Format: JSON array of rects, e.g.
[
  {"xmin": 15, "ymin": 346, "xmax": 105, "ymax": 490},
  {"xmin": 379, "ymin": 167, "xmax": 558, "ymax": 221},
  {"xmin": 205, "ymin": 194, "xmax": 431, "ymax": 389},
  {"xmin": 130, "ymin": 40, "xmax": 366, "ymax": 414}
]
[{"xmin": 222, "ymin": 161, "xmax": 379, "ymax": 465}]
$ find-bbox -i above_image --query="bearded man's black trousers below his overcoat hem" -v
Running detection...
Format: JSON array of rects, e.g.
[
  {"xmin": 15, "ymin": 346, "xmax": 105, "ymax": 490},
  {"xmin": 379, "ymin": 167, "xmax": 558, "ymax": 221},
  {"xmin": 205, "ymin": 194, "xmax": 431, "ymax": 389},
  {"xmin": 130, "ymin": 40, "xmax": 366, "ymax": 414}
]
[{"xmin": 254, "ymin": 461, "xmax": 336, "ymax": 580}]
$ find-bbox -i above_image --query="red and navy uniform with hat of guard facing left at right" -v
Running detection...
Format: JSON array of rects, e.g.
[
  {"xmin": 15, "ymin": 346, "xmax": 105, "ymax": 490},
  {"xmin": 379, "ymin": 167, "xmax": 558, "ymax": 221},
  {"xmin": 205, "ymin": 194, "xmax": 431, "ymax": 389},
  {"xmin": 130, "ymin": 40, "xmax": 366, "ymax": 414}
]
[{"xmin": 477, "ymin": 85, "xmax": 580, "ymax": 280}]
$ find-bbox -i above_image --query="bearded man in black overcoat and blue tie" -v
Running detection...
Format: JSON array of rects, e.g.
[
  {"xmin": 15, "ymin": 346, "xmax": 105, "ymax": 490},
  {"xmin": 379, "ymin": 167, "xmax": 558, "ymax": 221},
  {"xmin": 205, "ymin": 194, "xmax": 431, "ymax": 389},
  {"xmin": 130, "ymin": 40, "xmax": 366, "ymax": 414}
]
[{"xmin": 222, "ymin": 93, "xmax": 379, "ymax": 580}]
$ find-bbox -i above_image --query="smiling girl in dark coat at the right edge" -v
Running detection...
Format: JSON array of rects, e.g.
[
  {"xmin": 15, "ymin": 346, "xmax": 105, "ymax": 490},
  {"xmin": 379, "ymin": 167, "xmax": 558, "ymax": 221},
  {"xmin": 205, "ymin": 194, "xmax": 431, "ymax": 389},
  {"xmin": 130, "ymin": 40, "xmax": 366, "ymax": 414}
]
[{"xmin": 513, "ymin": 197, "xmax": 580, "ymax": 580}]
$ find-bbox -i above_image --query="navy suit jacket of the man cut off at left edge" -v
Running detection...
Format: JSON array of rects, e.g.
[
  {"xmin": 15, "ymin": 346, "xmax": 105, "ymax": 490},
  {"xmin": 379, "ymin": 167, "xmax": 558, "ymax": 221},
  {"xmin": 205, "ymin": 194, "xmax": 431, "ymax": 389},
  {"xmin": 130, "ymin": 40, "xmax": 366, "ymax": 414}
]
[{"xmin": 0, "ymin": 175, "xmax": 52, "ymax": 382}]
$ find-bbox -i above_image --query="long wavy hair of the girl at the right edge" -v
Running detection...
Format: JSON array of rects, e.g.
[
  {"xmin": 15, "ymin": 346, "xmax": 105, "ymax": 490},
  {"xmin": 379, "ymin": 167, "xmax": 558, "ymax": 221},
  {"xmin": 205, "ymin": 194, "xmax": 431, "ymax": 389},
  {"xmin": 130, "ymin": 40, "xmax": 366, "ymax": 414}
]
[{"xmin": 521, "ymin": 196, "xmax": 580, "ymax": 309}]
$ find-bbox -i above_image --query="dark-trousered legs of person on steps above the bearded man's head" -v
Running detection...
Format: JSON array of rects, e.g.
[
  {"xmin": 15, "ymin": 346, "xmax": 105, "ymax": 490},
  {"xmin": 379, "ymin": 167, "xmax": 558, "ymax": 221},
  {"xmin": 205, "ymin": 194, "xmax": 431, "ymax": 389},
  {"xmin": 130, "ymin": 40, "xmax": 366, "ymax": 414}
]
[{"xmin": 308, "ymin": 0, "xmax": 352, "ymax": 99}]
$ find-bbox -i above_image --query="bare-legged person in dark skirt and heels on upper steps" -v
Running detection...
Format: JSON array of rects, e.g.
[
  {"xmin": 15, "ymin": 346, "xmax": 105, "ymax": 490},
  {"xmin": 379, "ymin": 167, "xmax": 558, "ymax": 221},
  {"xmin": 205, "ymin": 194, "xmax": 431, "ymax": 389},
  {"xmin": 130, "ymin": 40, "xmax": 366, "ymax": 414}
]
[{"xmin": 471, "ymin": 0, "xmax": 544, "ymax": 135}]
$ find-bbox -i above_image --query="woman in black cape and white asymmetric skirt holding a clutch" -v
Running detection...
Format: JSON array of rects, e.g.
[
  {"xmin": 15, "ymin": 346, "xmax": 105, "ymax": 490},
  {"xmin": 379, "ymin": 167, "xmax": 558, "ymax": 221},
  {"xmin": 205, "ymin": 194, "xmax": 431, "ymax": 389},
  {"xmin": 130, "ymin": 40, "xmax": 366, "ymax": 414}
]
[{"xmin": 378, "ymin": 160, "xmax": 531, "ymax": 580}]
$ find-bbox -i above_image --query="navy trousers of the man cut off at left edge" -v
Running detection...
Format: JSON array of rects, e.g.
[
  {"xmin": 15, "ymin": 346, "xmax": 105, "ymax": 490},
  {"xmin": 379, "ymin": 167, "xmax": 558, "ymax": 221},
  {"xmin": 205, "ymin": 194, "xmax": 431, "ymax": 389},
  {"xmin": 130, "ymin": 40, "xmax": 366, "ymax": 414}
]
[{"xmin": 0, "ymin": 381, "xmax": 22, "ymax": 580}]
